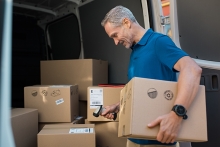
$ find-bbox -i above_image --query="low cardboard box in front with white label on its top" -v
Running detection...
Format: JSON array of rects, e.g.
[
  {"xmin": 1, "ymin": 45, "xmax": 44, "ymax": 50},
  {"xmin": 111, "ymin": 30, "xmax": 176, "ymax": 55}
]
[{"xmin": 37, "ymin": 124, "xmax": 95, "ymax": 147}]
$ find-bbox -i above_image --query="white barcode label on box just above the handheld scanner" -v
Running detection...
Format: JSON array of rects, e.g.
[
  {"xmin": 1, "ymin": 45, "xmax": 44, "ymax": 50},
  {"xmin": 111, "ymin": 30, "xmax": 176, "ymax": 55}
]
[{"xmin": 90, "ymin": 88, "xmax": 103, "ymax": 109}]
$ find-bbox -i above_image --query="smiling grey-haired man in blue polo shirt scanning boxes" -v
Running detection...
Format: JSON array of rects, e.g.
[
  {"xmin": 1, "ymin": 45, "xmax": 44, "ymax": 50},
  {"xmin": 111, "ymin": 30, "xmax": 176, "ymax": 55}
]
[{"xmin": 101, "ymin": 6, "xmax": 202, "ymax": 147}]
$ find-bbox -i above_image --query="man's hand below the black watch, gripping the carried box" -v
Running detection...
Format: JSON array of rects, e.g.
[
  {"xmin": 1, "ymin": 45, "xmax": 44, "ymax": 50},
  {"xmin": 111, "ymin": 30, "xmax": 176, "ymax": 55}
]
[{"xmin": 147, "ymin": 111, "xmax": 183, "ymax": 143}]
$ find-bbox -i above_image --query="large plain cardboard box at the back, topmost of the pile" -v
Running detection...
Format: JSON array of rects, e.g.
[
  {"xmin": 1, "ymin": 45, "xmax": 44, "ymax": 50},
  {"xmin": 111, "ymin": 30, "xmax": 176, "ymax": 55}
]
[{"xmin": 41, "ymin": 59, "xmax": 108, "ymax": 100}]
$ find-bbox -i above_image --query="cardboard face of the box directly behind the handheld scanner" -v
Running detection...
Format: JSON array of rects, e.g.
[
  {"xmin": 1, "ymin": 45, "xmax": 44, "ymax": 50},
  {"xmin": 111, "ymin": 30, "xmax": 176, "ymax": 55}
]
[{"xmin": 87, "ymin": 86, "xmax": 123, "ymax": 121}]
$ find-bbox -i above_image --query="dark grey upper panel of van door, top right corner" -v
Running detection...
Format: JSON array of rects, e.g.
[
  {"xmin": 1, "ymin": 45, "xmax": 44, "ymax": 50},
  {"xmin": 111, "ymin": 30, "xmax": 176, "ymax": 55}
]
[{"xmin": 177, "ymin": 0, "xmax": 220, "ymax": 62}]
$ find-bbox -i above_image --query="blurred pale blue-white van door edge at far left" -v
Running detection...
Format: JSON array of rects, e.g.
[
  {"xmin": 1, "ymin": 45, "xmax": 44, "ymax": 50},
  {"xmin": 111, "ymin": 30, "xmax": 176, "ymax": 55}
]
[{"xmin": 0, "ymin": 0, "xmax": 15, "ymax": 147}]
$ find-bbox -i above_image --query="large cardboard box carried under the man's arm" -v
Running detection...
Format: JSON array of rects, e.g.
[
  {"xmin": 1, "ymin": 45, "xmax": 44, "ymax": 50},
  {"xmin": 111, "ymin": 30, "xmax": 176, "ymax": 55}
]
[{"xmin": 118, "ymin": 78, "xmax": 207, "ymax": 142}]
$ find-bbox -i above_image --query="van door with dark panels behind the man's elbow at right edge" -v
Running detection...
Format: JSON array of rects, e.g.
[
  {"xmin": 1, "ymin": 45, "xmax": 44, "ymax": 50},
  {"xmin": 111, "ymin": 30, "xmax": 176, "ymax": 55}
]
[{"xmin": 170, "ymin": 0, "xmax": 220, "ymax": 147}]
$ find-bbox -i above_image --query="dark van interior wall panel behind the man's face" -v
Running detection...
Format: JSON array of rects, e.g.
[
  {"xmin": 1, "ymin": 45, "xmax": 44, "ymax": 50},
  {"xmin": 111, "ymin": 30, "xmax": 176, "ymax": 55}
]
[{"xmin": 79, "ymin": 0, "xmax": 144, "ymax": 83}]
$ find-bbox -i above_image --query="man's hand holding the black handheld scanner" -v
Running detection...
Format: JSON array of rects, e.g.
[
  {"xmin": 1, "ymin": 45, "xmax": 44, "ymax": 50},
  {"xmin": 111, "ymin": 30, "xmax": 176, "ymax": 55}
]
[{"xmin": 100, "ymin": 103, "xmax": 120, "ymax": 119}]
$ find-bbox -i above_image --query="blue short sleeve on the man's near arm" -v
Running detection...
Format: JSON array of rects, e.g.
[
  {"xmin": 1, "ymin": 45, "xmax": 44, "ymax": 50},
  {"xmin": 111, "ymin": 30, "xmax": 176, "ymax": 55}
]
[{"xmin": 155, "ymin": 35, "xmax": 188, "ymax": 71}]
